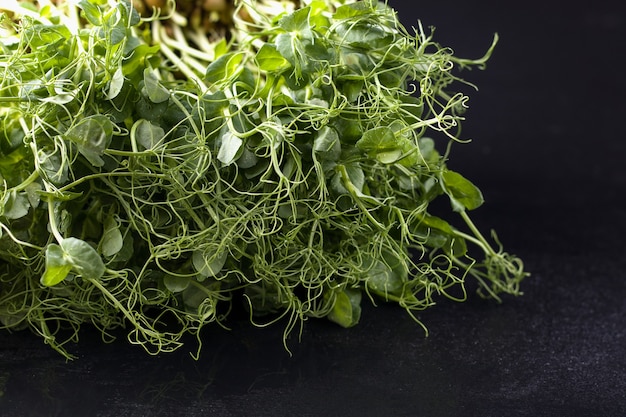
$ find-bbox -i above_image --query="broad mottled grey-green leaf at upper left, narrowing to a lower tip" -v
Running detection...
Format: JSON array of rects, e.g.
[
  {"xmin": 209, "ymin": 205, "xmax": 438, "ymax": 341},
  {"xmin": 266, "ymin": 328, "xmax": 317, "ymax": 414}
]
[{"xmin": 65, "ymin": 115, "xmax": 113, "ymax": 167}]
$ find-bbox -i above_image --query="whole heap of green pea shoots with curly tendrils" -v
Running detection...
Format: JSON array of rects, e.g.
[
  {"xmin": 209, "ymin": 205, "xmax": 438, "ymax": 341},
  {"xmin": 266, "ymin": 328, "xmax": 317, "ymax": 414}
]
[{"xmin": 0, "ymin": 0, "xmax": 526, "ymax": 357}]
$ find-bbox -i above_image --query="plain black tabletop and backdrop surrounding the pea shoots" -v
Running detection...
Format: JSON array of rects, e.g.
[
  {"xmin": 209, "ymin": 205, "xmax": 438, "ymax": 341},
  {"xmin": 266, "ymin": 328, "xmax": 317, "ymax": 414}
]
[{"xmin": 0, "ymin": 0, "xmax": 626, "ymax": 417}]
